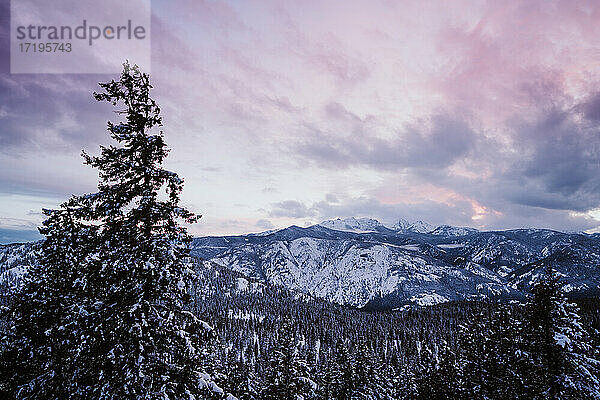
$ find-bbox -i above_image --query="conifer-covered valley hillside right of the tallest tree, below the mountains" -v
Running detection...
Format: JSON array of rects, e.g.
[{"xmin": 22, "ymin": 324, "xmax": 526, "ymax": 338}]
[{"xmin": 5, "ymin": 252, "xmax": 600, "ymax": 399}]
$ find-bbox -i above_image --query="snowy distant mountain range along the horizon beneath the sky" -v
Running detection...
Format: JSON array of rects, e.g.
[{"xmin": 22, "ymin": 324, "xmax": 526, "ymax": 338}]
[{"xmin": 0, "ymin": 218, "xmax": 600, "ymax": 309}]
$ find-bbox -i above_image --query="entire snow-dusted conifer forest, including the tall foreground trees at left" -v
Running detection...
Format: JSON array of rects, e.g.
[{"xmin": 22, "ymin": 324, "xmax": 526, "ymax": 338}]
[{"xmin": 0, "ymin": 64, "xmax": 600, "ymax": 400}]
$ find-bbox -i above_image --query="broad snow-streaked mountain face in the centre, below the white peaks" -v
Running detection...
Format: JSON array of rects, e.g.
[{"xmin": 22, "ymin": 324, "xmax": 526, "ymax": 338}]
[{"xmin": 207, "ymin": 237, "xmax": 510, "ymax": 307}]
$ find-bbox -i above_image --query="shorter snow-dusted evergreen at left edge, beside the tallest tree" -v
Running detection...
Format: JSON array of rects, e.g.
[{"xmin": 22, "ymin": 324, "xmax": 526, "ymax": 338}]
[{"xmin": 0, "ymin": 203, "xmax": 97, "ymax": 399}]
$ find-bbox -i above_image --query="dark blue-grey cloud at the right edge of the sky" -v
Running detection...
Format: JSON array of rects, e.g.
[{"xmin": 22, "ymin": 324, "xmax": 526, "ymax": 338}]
[{"xmin": 510, "ymin": 104, "xmax": 600, "ymax": 211}]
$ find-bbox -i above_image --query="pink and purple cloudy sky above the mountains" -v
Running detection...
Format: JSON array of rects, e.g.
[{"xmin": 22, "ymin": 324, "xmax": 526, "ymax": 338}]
[{"xmin": 0, "ymin": 0, "xmax": 600, "ymax": 243}]
